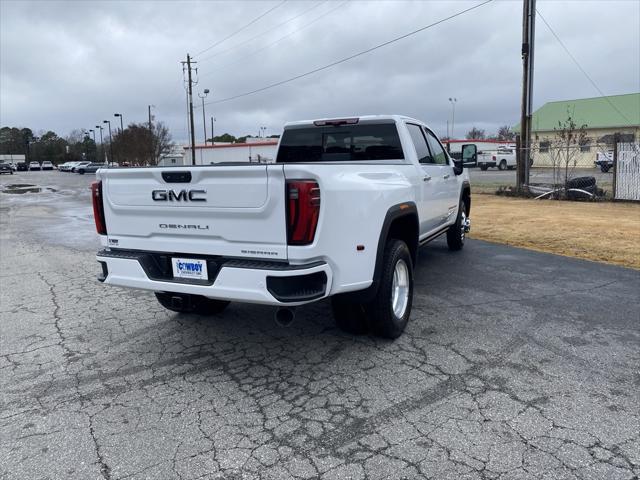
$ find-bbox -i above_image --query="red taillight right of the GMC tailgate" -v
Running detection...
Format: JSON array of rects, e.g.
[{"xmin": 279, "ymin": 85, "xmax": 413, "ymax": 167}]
[{"xmin": 287, "ymin": 180, "xmax": 320, "ymax": 245}]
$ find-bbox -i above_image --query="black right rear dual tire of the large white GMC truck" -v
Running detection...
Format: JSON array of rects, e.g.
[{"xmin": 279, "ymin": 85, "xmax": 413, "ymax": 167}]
[{"xmin": 365, "ymin": 238, "xmax": 413, "ymax": 339}]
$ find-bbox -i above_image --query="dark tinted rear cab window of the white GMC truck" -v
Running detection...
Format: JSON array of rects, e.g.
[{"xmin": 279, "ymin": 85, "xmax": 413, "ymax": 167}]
[{"xmin": 276, "ymin": 123, "xmax": 404, "ymax": 163}]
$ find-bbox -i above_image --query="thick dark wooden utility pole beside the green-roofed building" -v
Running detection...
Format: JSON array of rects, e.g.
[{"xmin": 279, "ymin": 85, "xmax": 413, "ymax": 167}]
[{"xmin": 517, "ymin": 0, "xmax": 536, "ymax": 191}]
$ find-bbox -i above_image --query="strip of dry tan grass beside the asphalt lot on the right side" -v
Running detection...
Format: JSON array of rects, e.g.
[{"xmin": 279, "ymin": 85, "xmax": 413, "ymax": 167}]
[{"xmin": 470, "ymin": 194, "xmax": 640, "ymax": 270}]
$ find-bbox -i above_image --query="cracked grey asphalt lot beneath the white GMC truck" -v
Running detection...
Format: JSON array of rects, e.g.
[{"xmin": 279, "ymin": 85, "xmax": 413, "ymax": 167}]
[{"xmin": 0, "ymin": 171, "xmax": 640, "ymax": 480}]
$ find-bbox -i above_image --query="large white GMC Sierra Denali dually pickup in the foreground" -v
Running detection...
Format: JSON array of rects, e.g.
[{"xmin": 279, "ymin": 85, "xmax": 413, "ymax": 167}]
[{"xmin": 92, "ymin": 115, "xmax": 471, "ymax": 338}]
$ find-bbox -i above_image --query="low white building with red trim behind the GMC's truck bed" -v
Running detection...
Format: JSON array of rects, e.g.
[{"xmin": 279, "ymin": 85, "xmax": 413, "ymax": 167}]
[{"xmin": 184, "ymin": 138, "xmax": 278, "ymax": 165}]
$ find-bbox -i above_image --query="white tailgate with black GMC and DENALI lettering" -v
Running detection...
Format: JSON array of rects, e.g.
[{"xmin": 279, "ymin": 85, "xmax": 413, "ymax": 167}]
[{"xmin": 97, "ymin": 164, "xmax": 287, "ymax": 260}]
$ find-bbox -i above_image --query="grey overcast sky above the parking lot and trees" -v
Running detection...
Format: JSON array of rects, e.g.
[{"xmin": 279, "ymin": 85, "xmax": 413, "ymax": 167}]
[{"xmin": 0, "ymin": 0, "xmax": 640, "ymax": 143}]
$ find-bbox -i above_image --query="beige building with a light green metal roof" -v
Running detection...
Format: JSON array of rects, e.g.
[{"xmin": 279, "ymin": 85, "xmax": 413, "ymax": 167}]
[{"xmin": 513, "ymin": 93, "xmax": 640, "ymax": 167}]
